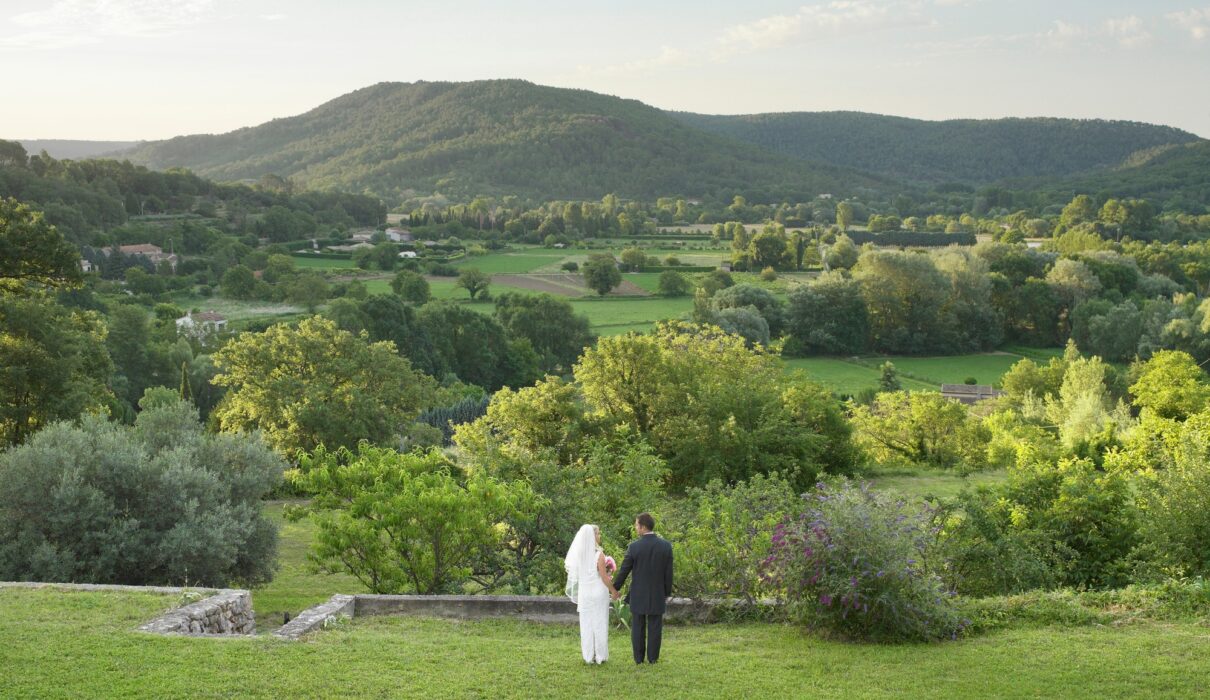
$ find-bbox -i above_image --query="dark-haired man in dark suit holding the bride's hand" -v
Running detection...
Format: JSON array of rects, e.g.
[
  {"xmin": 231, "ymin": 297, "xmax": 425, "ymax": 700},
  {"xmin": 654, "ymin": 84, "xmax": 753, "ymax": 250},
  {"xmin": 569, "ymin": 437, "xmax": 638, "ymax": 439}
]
[{"xmin": 613, "ymin": 513, "xmax": 673, "ymax": 664}]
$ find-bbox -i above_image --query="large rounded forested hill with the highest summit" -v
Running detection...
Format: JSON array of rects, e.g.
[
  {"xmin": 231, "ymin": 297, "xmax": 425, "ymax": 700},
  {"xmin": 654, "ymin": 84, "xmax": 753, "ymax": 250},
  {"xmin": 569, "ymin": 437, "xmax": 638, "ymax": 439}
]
[{"xmin": 123, "ymin": 80, "xmax": 878, "ymax": 201}]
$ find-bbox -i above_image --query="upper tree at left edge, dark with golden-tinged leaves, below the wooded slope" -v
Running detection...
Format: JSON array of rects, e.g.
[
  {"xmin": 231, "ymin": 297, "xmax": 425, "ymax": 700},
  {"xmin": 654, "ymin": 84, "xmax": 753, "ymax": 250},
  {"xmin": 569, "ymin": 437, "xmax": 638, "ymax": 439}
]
[{"xmin": 0, "ymin": 198, "xmax": 82, "ymax": 294}]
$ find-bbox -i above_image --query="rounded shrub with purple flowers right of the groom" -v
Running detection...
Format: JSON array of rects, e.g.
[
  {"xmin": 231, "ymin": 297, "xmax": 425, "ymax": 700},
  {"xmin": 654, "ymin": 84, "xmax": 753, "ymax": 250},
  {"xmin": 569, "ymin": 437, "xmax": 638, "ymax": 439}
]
[{"xmin": 764, "ymin": 479, "xmax": 966, "ymax": 641}]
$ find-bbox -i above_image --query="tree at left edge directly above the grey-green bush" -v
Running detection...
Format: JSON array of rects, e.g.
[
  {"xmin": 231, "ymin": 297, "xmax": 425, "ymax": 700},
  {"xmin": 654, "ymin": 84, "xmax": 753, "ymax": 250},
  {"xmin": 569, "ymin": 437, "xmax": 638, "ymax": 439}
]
[{"xmin": 0, "ymin": 294, "xmax": 113, "ymax": 445}]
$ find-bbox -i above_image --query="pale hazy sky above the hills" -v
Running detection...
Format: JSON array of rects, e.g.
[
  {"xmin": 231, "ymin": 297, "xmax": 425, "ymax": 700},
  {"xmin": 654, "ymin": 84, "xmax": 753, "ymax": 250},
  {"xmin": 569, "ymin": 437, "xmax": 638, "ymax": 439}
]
[{"xmin": 0, "ymin": 0, "xmax": 1210, "ymax": 140}]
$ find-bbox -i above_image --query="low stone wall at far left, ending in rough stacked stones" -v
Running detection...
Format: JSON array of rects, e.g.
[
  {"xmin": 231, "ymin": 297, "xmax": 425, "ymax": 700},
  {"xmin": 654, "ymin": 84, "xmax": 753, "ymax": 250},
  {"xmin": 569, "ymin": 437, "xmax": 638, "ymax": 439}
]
[{"xmin": 0, "ymin": 582, "xmax": 257, "ymax": 637}]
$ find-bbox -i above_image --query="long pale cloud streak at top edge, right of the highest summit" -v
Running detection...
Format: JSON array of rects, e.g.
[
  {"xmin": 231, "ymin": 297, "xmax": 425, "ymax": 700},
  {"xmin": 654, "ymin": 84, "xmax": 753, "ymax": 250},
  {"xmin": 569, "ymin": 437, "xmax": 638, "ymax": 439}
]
[{"xmin": 715, "ymin": 0, "xmax": 929, "ymax": 58}]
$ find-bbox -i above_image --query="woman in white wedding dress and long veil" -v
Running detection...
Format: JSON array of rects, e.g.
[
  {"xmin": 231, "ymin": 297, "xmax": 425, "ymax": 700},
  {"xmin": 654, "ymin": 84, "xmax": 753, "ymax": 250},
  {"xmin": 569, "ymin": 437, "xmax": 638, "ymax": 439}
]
[{"xmin": 563, "ymin": 525, "xmax": 617, "ymax": 664}]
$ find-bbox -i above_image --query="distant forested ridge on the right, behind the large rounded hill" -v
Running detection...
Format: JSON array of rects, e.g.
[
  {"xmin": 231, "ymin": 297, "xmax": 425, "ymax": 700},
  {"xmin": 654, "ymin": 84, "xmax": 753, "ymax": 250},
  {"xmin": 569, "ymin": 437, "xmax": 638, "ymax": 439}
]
[{"xmin": 669, "ymin": 111, "xmax": 1199, "ymax": 185}]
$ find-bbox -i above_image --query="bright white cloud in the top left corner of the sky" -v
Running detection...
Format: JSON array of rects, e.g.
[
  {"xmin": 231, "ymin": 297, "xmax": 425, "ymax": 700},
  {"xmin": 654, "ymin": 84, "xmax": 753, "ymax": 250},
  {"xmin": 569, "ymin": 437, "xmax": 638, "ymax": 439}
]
[{"xmin": 0, "ymin": 0, "xmax": 214, "ymax": 50}]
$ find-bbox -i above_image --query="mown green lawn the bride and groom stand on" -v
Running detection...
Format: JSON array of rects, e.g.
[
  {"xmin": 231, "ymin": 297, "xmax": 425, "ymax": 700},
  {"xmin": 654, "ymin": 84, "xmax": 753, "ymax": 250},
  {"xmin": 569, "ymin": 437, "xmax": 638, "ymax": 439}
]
[{"xmin": 0, "ymin": 590, "xmax": 1210, "ymax": 699}]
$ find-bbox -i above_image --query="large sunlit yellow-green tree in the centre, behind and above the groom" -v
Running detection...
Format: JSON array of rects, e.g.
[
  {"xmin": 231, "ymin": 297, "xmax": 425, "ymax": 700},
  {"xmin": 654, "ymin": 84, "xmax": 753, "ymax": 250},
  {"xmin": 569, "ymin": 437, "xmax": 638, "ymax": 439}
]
[{"xmin": 575, "ymin": 322, "xmax": 848, "ymax": 487}]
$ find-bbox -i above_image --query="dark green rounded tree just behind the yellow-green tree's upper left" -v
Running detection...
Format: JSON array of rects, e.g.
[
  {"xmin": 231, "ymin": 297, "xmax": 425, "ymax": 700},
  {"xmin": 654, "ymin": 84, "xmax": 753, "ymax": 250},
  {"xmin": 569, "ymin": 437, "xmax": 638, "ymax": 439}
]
[{"xmin": 496, "ymin": 293, "xmax": 593, "ymax": 372}]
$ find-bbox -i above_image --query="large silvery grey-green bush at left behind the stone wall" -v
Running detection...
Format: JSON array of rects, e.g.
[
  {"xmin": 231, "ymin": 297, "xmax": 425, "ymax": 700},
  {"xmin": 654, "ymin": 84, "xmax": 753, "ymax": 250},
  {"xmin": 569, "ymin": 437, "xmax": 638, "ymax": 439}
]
[{"xmin": 0, "ymin": 399, "xmax": 283, "ymax": 586}]
